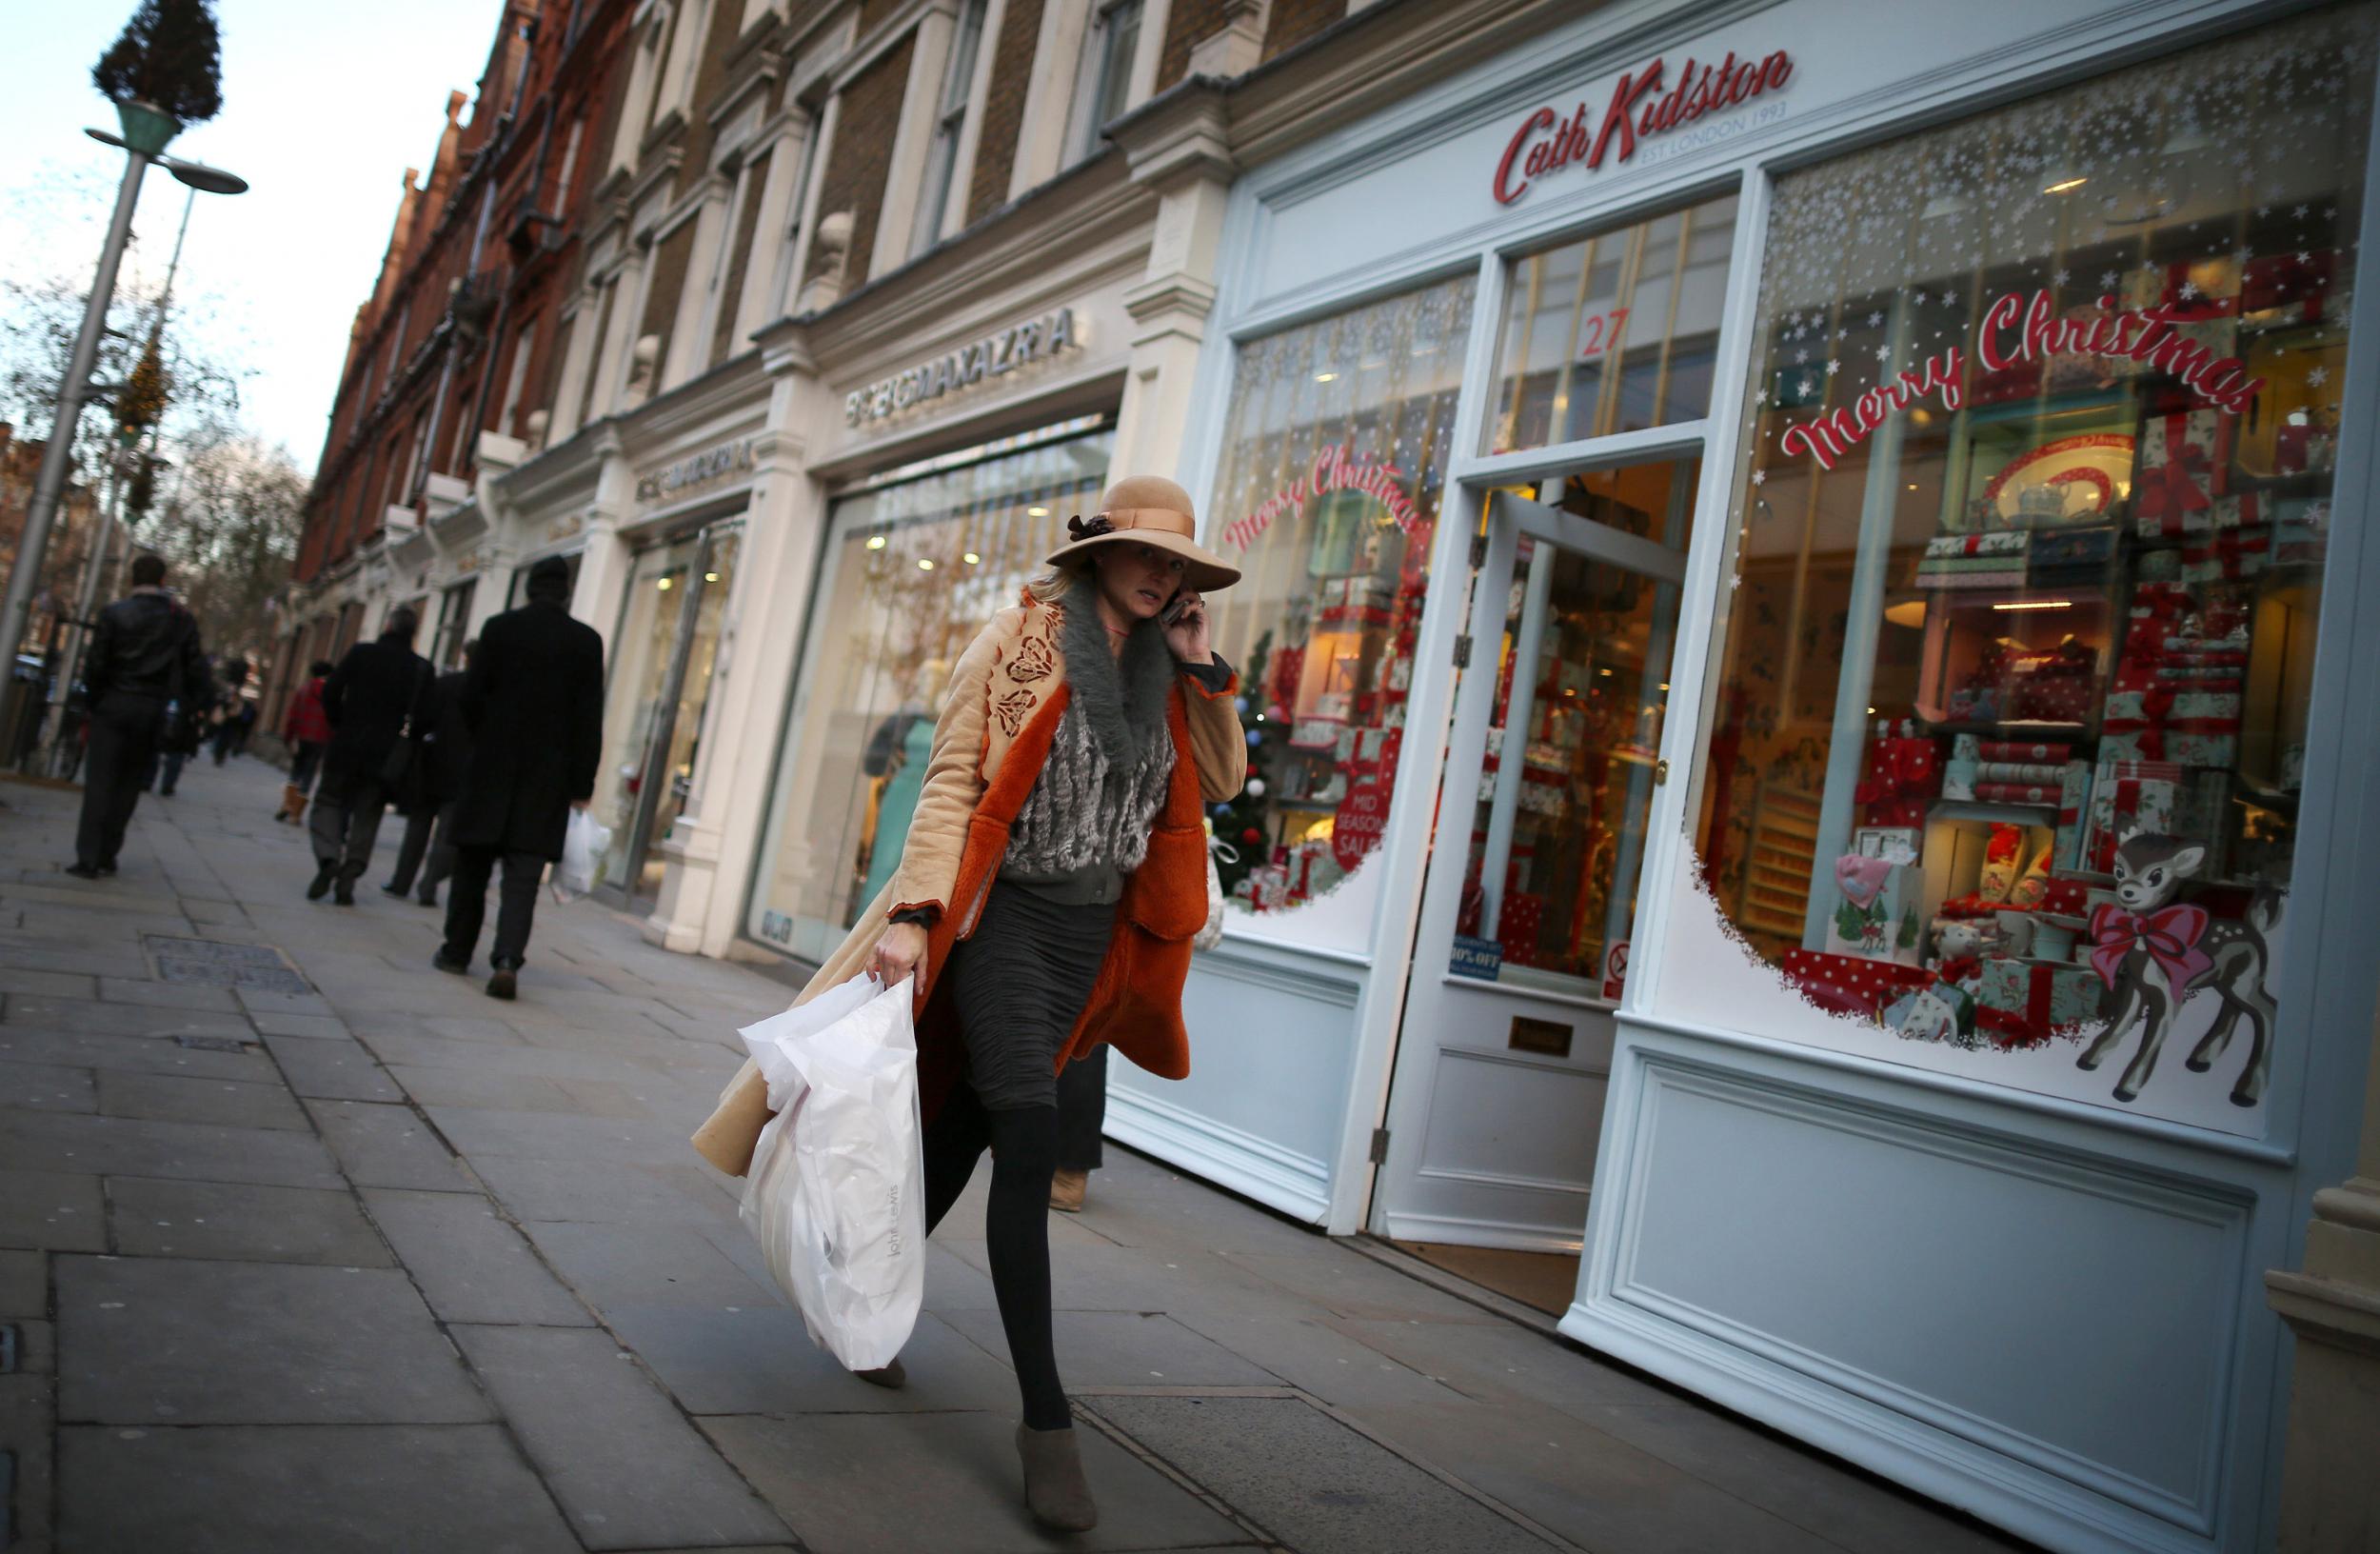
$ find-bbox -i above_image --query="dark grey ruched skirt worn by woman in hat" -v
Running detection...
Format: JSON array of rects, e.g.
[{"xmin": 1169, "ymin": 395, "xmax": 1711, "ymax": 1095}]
[{"xmin": 947, "ymin": 881, "xmax": 1117, "ymax": 1111}]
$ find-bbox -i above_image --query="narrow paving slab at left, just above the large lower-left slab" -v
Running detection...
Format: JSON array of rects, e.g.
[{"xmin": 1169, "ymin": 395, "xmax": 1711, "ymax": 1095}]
[{"xmin": 108, "ymin": 1176, "xmax": 395, "ymax": 1268}]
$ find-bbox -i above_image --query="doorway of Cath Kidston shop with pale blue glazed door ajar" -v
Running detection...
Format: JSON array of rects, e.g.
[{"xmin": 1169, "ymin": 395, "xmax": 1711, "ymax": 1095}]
[{"xmin": 1374, "ymin": 459, "xmax": 1697, "ymax": 1311}]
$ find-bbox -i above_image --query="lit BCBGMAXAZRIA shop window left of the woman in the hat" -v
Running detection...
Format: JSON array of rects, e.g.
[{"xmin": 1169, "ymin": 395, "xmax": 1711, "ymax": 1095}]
[{"xmin": 750, "ymin": 416, "xmax": 1114, "ymax": 959}]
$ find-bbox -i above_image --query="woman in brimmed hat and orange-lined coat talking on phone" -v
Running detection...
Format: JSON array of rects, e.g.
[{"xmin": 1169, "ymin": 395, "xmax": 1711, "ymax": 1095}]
[{"xmin": 695, "ymin": 476, "xmax": 1247, "ymax": 1530}]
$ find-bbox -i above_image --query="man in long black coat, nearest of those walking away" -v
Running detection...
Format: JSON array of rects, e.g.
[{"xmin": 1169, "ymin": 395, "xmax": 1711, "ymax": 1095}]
[{"xmin": 431, "ymin": 557, "xmax": 603, "ymax": 997}]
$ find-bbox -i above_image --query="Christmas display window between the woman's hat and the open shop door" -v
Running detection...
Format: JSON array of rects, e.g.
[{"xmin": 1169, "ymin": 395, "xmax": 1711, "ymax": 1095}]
[{"xmin": 1212, "ymin": 276, "xmax": 1478, "ymax": 911}]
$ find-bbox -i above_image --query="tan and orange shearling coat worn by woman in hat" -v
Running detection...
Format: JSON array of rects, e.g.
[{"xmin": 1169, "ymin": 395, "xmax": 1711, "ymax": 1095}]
[{"xmin": 693, "ymin": 595, "xmax": 1247, "ymax": 1176}]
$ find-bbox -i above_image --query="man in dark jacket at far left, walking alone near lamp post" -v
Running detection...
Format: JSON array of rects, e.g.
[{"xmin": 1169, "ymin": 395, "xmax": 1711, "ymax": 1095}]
[{"xmin": 67, "ymin": 557, "xmax": 212, "ymax": 881}]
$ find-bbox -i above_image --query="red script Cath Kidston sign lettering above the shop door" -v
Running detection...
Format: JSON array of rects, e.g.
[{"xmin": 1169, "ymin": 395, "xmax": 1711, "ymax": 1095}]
[{"xmin": 1495, "ymin": 48, "xmax": 1793, "ymax": 205}]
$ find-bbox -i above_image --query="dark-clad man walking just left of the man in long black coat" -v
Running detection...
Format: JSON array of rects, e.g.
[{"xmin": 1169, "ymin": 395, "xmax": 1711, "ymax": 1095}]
[{"xmin": 305, "ymin": 609, "xmax": 438, "ymax": 906}]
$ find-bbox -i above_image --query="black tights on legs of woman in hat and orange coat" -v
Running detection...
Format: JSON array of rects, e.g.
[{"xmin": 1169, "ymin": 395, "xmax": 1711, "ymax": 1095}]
[{"xmin": 926, "ymin": 1081, "xmax": 1074, "ymax": 1430}]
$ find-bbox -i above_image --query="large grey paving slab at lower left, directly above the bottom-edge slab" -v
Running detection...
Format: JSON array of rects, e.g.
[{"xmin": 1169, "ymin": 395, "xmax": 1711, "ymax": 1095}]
[{"xmin": 52, "ymin": 1257, "xmax": 493, "ymax": 1425}]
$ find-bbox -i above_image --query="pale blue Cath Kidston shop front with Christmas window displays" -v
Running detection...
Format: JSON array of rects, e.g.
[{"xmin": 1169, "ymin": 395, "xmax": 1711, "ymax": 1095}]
[{"xmin": 1128, "ymin": 0, "xmax": 2380, "ymax": 1549}]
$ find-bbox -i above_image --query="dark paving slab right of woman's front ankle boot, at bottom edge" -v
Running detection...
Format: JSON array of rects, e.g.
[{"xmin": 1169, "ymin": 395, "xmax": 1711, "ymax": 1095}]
[{"xmin": 1090, "ymin": 1397, "xmax": 1557, "ymax": 1554}]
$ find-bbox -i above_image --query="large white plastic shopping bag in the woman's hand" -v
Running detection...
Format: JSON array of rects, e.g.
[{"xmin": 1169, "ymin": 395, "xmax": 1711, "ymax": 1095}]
[{"xmin": 741, "ymin": 976, "xmax": 926, "ymax": 1371}]
